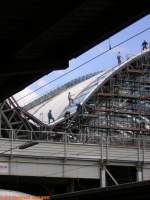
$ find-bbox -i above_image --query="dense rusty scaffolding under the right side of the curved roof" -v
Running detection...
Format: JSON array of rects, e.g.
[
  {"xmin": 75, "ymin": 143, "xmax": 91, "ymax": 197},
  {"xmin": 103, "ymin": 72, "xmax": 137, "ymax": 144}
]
[{"xmin": 54, "ymin": 50, "xmax": 150, "ymax": 142}]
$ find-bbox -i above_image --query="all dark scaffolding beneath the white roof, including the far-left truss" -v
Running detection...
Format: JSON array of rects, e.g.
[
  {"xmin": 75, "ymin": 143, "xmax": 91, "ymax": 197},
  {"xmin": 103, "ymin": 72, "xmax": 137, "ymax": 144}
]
[{"xmin": 0, "ymin": 51, "xmax": 150, "ymax": 143}]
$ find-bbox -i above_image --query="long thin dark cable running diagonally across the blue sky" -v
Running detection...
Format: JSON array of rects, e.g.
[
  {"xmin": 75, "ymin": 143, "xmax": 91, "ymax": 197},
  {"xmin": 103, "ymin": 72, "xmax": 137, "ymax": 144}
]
[{"xmin": 17, "ymin": 27, "xmax": 150, "ymax": 101}]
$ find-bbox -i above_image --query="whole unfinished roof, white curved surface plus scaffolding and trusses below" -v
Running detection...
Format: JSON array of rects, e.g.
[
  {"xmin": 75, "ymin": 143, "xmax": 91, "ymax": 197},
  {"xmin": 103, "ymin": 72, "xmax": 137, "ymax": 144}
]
[{"xmin": 1, "ymin": 49, "xmax": 150, "ymax": 143}]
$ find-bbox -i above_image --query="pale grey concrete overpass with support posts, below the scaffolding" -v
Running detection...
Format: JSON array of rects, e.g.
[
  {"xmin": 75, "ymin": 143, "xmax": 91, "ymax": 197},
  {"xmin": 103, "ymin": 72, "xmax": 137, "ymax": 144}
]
[{"xmin": 0, "ymin": 130, "xmax": 150, "ymax": 187}]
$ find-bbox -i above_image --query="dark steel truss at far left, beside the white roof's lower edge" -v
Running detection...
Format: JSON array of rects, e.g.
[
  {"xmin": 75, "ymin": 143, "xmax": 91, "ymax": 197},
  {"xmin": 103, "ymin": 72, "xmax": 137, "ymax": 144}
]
[{"xmin": 0, "ymin": 97, "xmax": 48, "ymax": 139}]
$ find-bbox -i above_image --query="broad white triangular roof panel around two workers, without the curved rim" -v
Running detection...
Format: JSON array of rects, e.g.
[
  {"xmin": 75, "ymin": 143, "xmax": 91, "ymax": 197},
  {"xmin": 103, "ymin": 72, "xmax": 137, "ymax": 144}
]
[{"xmin": 28, "ymin": 72, "xmax": 102, "ymax": 124}]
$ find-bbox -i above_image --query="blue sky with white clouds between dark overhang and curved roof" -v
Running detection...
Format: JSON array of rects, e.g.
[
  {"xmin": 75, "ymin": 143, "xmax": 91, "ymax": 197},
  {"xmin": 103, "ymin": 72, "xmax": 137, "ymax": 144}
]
[{"xmin": 14, "ymin": 14, "xmax": 150, "ymax": 106}]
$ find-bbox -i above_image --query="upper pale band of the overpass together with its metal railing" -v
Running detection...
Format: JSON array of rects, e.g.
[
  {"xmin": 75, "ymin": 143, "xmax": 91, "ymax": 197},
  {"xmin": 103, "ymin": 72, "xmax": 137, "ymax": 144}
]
[{"xmin": 0, "ymin": 129, "xmax": 150, "ymax": 162}]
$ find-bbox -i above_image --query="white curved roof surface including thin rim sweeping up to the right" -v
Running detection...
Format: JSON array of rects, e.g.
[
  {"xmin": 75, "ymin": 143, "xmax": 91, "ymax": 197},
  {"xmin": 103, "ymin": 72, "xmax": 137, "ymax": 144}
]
[{"xmin": 29, "ymin": 49, "xmax": 150, "ymax": 124}]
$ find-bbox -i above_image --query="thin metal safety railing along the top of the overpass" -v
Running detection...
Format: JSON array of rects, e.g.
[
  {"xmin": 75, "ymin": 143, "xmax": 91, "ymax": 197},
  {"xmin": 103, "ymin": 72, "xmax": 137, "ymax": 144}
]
[{"xmin": 0, "ymin": 129, "xmax": 150, "ymax": 147}]
